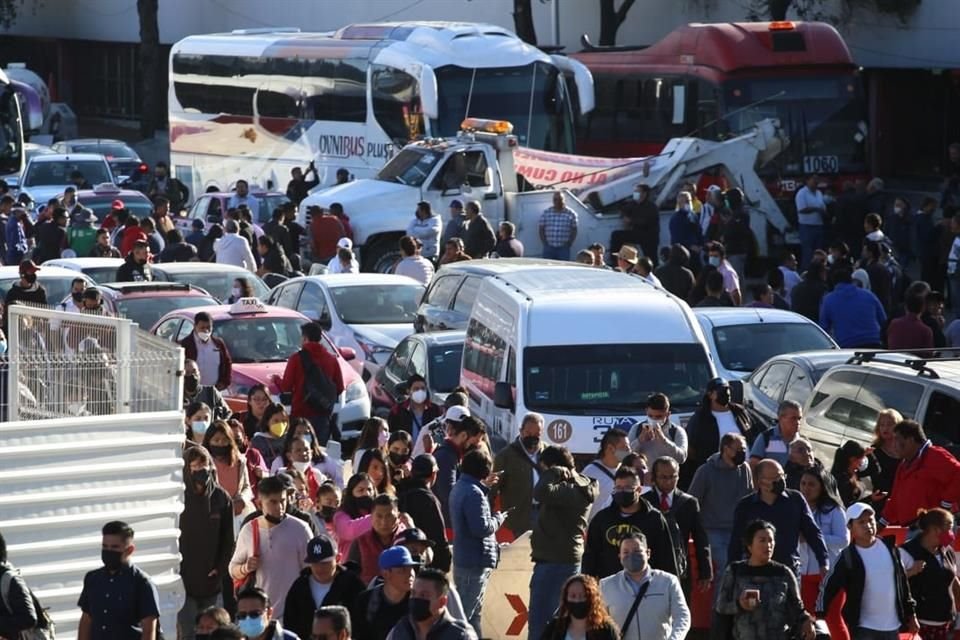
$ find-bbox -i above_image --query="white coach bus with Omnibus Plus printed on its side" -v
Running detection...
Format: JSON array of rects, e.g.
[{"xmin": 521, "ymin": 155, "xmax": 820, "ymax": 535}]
[{"xmin": 168, "ymin": 22, "xmax": 593, "ymax": 199}]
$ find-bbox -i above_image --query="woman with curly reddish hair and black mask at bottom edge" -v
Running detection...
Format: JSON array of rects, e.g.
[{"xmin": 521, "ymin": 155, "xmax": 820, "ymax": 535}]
[{"xmin": 541, "ymin": 575, "xmax": 620, "ymax": 640}]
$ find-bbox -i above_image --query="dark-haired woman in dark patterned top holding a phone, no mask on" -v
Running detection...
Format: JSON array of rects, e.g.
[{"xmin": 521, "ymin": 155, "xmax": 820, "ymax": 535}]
[{"xmin": 716, "ymin": 520, "xmax": 815, "ymax": 640}]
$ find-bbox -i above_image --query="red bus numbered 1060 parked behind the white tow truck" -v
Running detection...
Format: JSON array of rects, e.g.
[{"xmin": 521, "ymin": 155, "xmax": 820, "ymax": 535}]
[{"xmin": 572, "ymin": 22, "xmax": 867, "ymax": 198}]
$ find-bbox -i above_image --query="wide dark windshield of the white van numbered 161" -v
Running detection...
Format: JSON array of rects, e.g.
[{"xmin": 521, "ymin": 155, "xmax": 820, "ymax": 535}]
[{"xmin": 523, "ymin": 344, "xmax": 712, "ymax": 415}]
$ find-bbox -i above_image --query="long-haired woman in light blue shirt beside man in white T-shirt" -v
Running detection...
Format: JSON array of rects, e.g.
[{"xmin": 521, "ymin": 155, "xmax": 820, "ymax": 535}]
[{"xmin": 797, "ymin": 467, "xmax": 850, "ymax": 611}]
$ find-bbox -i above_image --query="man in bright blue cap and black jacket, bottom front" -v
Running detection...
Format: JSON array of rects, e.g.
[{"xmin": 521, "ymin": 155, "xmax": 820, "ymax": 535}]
[{"xmin": 350, "ymin": 546, "xmax": 420, "ymax": 640}]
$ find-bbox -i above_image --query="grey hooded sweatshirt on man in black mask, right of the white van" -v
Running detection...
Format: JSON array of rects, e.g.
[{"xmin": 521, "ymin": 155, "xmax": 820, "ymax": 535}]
[{"xmin": 690, "ymin": 453, "xmax": 753, "ymax": 530}]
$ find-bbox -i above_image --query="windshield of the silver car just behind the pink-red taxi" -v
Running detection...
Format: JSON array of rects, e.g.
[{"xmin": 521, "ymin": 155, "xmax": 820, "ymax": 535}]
[{"xmin": 330, "ymin": 284, "xmax": 423, "ymax": 324}]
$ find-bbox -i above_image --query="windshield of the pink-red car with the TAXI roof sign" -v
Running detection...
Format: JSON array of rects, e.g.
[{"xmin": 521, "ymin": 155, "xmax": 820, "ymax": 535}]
[{"xmin": 213, "ymin": 316, "xmax": 303, "ymax": 364}]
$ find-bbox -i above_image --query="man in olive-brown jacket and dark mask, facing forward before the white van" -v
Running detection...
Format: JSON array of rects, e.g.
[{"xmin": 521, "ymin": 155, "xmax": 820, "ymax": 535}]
[{"xmin": 491, "ymin": 413, "xmax": 545, "ymax": 538}]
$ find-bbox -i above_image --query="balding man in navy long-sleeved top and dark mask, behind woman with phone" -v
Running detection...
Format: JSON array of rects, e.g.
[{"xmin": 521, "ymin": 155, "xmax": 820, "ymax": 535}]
[{"xmin": 727, "ymin": 459, "xmax": 830, "ymax": 576}]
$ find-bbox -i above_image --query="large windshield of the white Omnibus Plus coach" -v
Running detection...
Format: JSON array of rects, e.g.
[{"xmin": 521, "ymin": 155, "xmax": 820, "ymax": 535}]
[{"xmin": 433, "ymin": 62, "xmax": 574, "ymax": 153}]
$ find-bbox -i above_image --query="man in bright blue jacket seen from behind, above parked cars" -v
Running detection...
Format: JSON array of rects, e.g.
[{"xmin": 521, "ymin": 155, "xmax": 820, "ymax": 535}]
[{"xmin": 819, "ymin": 267, "xmax": 887, "ymax": 349}]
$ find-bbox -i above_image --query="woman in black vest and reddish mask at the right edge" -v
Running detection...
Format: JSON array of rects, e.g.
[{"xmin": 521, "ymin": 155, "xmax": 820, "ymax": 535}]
[{"xmin": 900, "ymin": 509, "xmax": 960, "ymax": 640}]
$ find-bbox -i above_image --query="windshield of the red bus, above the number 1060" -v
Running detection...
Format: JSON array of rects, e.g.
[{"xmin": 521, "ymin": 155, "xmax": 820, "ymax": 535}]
[{"xmin": 722, "ymin": 74, "xmax": 866, "ymax": 175}]
